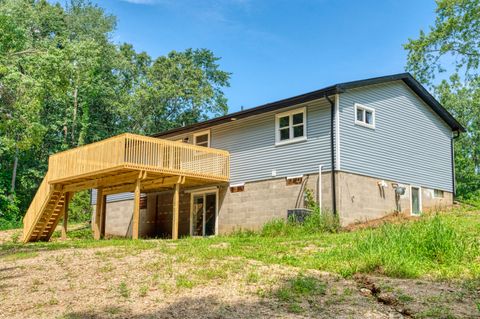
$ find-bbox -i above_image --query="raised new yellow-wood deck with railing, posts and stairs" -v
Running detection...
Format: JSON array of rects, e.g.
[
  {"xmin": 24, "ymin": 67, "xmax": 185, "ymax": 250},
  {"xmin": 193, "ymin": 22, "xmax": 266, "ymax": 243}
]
[{"xmin": 23, "ymin": 134, "xmax": 230, "ymax": 242}]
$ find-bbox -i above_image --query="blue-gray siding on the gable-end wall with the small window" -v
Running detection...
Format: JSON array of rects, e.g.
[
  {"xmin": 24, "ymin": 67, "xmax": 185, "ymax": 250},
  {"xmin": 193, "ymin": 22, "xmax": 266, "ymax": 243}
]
[{"xmin": 339, "ymin": 81, "xmax": 453, "ymax": 192}]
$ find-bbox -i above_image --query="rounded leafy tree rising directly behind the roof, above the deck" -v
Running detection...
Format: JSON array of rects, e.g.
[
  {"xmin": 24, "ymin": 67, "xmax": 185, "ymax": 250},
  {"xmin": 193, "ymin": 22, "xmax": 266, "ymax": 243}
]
[{"xmin": 128, "ymin": 49, "xmax": 230, "ymax": 134}]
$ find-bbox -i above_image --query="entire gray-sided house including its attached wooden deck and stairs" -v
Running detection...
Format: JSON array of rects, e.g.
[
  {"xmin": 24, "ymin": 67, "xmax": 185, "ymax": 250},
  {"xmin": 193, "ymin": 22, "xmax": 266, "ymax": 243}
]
[{"xmin": 19, "ymin": 73, "xmax": 465, "ymax": 242}]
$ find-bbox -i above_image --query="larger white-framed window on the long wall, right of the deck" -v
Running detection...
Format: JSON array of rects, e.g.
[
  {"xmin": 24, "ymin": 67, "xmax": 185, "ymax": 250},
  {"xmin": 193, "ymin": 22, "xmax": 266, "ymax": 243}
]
[{"xmin": 275, "ymin": 108, "xmax": 307, "ymax": 145}]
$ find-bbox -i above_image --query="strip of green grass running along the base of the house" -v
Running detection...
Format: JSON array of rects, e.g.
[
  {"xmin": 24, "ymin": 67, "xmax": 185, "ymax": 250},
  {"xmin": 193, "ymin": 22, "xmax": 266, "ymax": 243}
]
[{"xmin": 0, "ymin": 210, "xmax": 480, "ymax": 280}]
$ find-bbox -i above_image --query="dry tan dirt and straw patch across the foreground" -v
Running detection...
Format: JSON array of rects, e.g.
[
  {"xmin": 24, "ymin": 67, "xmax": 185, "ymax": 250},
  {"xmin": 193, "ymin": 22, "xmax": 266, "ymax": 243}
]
[{"xmin": 0, "ymin": 241, "xmax": 480, "ymax": 319}]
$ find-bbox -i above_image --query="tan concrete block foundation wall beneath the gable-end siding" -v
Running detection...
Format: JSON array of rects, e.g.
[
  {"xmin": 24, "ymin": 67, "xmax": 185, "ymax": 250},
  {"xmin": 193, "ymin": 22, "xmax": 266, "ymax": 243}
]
[{"xmin": 337, "ymin": 172, "xmax": 453, "ymax": 225}]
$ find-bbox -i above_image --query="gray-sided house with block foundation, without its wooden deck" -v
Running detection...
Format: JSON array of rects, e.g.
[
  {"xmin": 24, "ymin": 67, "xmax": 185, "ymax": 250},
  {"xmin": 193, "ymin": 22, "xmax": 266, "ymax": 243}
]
[{"xmin": 92, "ymin": 73, "xmax": 465, "ymax": 236}]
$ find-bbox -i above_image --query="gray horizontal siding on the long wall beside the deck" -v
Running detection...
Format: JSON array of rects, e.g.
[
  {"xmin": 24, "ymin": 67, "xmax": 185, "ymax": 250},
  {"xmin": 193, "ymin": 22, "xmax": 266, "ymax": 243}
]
[{"xmin": 169, "ymin": 99, "xmax": 330, "ymax": 183}]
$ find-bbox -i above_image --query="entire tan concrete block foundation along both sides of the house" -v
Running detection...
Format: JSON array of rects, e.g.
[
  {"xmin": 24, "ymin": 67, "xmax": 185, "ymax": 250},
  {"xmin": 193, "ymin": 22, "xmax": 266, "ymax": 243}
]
[{"xmin": 94, "ymin": 171, "xmax": 453, "ymax": 238}]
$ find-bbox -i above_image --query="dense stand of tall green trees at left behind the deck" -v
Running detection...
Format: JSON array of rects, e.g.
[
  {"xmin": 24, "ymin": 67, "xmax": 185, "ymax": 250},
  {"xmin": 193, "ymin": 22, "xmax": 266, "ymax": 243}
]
[{"xmin": 0, "ymin": 0, "xmax": 230, "ymax": 225}]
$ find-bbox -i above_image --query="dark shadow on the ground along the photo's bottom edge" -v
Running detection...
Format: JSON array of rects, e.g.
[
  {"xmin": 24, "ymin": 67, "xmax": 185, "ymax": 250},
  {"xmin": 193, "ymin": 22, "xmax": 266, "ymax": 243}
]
[{"xmin": 61, "ymin": 274, "xmax": 344, "ymax": 319}]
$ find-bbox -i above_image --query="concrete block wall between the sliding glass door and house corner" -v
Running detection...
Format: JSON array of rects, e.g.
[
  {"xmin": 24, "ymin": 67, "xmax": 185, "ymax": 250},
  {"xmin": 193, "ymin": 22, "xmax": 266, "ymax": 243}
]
[{"xmin": 218, "ymin": 173, "xmax": 332, "ymax": 234}]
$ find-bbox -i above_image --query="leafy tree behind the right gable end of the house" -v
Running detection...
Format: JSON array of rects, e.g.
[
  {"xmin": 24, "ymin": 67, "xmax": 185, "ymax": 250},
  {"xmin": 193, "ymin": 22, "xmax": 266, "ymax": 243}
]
[{"xmin": 405, "ymin": 0, "xmax": 480, "ymax": 198}]
